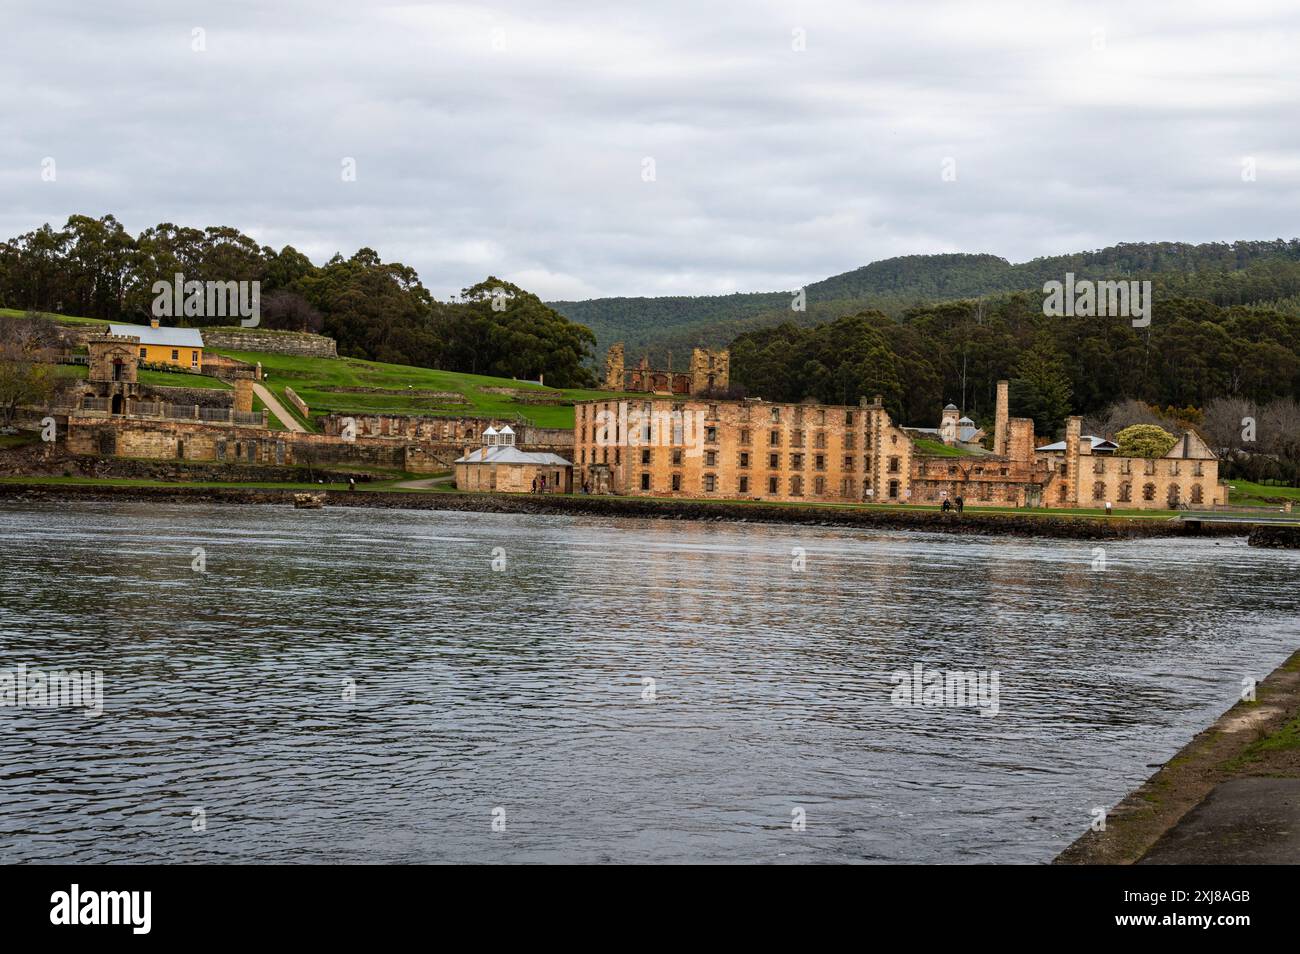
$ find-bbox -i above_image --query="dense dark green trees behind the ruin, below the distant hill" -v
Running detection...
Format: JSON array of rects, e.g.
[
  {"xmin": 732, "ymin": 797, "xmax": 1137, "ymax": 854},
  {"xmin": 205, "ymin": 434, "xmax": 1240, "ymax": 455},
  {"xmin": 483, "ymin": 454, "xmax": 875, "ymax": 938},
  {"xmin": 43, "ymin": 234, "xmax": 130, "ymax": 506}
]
[{"xmin": 731, "ymin": 292, "xmax": 1300, "ymax": 435}]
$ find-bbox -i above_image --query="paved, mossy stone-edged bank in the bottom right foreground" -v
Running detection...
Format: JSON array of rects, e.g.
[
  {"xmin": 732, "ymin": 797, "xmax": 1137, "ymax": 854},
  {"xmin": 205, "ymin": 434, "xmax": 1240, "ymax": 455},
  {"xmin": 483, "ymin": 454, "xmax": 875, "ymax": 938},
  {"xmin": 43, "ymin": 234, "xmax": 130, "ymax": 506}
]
[{"xmin": 1052, "ymin": 651, "xmax": 1300, "ymax": 864}]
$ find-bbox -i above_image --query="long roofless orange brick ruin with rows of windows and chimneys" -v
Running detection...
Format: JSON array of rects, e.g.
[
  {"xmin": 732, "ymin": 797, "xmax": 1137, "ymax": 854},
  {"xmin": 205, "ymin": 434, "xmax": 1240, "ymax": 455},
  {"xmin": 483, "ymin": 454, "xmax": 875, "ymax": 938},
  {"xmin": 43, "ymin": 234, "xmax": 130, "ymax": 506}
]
[{"xmin": 573, "ymin": 381, "xmax": 1227, "ymax": 509}]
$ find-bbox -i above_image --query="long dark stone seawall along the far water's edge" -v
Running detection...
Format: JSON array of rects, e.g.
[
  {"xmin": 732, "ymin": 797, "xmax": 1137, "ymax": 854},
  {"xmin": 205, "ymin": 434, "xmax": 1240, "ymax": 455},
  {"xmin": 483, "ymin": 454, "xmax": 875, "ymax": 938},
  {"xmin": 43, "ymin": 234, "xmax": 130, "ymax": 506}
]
[{"xmin": 0, "ymin": 481, "xmax": 1251, "ymax": 539}]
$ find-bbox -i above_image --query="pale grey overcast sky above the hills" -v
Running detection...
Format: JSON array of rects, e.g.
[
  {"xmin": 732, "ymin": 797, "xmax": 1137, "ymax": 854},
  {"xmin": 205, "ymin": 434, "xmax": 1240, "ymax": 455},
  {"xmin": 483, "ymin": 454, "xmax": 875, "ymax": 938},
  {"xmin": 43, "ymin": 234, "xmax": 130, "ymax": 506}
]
[{"xmin": 0, "ymin": 0, "xmax": 1300, "ymax": 299}]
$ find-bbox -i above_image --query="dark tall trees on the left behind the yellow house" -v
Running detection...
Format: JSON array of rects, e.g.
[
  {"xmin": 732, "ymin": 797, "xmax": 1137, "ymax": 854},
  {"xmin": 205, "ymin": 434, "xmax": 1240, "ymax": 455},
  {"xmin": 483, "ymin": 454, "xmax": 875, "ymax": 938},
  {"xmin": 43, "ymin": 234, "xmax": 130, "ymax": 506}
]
[{"xmin": 0, "ymin": 216, "xmax": 595, "ymax": 387}]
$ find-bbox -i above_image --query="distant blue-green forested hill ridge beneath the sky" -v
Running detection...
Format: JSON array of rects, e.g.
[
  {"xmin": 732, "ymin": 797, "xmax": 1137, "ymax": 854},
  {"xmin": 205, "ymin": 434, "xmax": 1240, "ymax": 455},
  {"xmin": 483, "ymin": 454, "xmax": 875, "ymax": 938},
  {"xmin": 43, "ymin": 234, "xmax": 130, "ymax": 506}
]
[{"xmin": 547, "ymin": 239, "xmax": 1300, "ymax": 359}]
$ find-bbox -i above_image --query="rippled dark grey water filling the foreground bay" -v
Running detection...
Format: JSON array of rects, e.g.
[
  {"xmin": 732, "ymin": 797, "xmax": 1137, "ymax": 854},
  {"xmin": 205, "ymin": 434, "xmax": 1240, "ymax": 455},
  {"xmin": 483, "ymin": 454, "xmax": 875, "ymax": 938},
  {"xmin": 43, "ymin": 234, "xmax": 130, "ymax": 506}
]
[{"xmin": 0, "ymin": 503, "xmax": 1300, "ymax": 862}]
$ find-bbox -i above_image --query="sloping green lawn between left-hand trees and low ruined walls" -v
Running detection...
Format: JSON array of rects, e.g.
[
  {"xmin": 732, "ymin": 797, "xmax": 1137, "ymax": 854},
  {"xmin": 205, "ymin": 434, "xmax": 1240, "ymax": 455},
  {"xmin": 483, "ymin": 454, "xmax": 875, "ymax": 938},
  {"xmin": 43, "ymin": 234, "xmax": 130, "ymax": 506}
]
[{"xmin": 216, "ymin": 348, "xmax": 631, "ymax": 428}]
